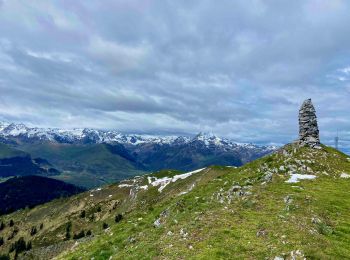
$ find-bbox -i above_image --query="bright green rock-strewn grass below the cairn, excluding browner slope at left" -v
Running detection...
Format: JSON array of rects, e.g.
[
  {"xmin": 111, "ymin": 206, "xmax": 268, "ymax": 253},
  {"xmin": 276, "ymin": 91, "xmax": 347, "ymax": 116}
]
[{"xmin": 61, "ymin": 147, "xmax": 350, "ymax": 259}]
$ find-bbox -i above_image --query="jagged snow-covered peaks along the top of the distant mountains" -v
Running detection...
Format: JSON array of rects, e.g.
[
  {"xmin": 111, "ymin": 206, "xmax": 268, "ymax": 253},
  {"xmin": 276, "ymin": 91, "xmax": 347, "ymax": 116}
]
[{"xmin": 0, "ymin": 122, "xmax": 275, "ymax": 151}]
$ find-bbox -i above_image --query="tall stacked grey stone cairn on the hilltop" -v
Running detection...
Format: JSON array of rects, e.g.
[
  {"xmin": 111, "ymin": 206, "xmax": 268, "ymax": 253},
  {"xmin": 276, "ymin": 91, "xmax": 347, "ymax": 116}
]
[{"xmin": 298, "ymin": 99, "xmax": 320, "ymax": 148}]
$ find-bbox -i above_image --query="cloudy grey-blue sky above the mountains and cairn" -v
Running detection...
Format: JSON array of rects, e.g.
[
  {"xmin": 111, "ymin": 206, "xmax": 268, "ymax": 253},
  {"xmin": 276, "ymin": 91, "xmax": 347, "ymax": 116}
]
[{"xmin": 0, "ymin": 0, "xmax": 350, "ymax": 149}]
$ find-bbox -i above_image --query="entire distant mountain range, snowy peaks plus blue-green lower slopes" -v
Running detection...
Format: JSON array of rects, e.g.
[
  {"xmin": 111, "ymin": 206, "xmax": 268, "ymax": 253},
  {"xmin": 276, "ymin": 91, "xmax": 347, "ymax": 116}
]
[{"xmin": 0, "ymin": 122, "xmax": 276, "ymax": 188}]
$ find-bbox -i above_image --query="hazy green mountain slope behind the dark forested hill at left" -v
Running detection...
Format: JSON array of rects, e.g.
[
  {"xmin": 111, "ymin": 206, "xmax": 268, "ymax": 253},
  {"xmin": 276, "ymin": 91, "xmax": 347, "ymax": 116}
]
[{"xmin": 16, "ymin": 143, "xmax": 142, "ymax": 188}]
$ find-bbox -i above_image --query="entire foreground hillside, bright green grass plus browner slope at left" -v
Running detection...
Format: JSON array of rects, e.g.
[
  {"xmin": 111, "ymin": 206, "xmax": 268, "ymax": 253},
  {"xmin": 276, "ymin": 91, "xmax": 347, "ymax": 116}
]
[{"xmin": 0, "ymin": 145, "xmax": 350, "ymax": 259}]
